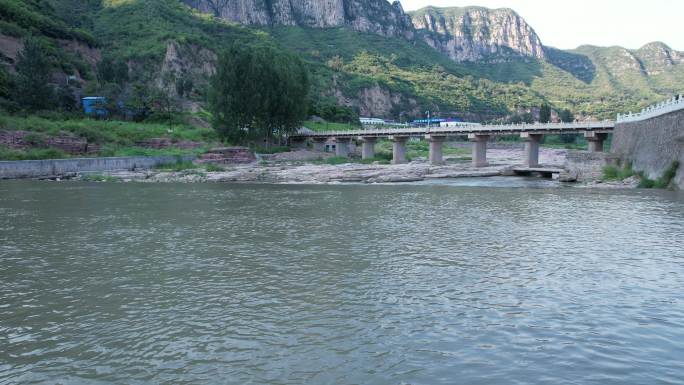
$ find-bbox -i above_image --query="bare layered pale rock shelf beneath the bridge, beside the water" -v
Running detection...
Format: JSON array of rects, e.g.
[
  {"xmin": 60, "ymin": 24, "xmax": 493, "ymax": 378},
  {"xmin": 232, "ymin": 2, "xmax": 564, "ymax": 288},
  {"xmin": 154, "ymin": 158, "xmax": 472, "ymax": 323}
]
[{"xmin": 67, "ymin": 148, "xmax": 629, "ymax": 187}]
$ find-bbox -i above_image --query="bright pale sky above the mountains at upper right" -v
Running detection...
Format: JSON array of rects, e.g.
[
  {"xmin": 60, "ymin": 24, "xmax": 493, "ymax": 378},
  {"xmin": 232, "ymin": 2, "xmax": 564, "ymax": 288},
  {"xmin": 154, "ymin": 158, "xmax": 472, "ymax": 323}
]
[{"xmin": 401, "ymin": 0, "xmax": 684, "ymax": 51}]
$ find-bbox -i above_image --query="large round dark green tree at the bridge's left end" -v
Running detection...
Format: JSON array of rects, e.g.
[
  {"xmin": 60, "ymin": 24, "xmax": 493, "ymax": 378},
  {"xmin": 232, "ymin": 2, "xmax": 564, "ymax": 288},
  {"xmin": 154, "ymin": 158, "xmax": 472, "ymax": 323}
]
[{"xmin": 209, "ymin": 45, "xmax": 309, "ymax": 142}]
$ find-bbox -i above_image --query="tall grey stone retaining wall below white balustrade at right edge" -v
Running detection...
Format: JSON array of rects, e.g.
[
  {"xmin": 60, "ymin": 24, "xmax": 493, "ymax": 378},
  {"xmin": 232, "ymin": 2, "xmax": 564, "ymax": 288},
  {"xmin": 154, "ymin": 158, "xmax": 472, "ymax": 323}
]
[{"xmin": 611, "ymin": 110, "xmax": 684, "ymax": 189}]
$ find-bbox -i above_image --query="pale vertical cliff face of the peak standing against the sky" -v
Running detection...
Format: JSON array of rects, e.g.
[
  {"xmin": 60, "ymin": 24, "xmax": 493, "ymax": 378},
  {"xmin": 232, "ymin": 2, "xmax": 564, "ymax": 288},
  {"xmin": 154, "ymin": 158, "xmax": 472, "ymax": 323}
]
[{"xmin": 410, "ymin": 7, "xmax": 544, "ymax": 62}]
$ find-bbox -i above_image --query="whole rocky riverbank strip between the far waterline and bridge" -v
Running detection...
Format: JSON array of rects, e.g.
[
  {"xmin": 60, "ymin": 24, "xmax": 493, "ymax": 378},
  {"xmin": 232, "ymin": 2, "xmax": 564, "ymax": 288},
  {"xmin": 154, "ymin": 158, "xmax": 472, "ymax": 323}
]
[{"xmin": 0, "ymin": 145, "xmax": 639, "ymax": 188}]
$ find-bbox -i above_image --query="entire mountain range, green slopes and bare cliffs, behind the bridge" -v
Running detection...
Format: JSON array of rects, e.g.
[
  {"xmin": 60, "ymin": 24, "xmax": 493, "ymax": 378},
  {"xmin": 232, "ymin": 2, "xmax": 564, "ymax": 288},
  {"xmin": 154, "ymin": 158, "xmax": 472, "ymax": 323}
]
[{"xmin": 0, "ymin": 0, "xmax": 684, "ymax": 120}]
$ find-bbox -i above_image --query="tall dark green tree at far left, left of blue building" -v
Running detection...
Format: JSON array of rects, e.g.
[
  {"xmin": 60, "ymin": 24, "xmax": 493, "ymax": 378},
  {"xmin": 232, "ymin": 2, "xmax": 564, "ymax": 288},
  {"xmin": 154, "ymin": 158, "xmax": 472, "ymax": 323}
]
[{"xmin": 14, "ymin": 37, "xmax": 54, "ymax": 111}]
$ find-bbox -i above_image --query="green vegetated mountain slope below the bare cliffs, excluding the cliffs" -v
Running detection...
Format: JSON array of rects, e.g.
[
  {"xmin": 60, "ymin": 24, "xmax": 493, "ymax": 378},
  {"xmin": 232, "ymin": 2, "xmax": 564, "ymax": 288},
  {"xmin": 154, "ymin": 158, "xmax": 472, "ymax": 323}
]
[{"xmin": 0, "ymin": 0, "xmax": 684, "ymax": 120}]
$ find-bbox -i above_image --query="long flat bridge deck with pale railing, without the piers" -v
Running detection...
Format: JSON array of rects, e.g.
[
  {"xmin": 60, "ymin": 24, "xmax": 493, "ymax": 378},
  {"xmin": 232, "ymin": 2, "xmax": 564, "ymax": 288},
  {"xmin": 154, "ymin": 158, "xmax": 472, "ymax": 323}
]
[{"xmin": 290, "ymin": 121, "xmax": 615, "ymax": 138}]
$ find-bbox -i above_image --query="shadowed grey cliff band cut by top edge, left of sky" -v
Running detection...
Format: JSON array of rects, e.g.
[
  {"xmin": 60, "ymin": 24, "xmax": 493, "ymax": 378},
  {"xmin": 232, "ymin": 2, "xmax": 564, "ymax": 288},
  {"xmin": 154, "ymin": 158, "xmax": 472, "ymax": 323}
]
[{"xmin": 184, "ymin": 0, "xmax": 414, "ymax": 39}]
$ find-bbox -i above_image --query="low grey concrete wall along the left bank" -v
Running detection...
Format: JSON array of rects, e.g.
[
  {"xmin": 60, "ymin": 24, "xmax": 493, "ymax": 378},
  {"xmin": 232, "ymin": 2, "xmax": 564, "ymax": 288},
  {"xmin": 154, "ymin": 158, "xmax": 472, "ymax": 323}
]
[{"xmin": 0, "ymin": 156, "xmax": 195, "ymax": 179}]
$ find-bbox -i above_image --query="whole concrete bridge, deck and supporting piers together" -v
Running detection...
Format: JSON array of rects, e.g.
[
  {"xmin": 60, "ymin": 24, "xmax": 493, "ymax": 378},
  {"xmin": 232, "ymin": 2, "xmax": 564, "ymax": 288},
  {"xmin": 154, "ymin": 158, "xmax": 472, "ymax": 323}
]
[{"xmin": 290, "ymin": 121, "xmax": 615, "ymax": 168}]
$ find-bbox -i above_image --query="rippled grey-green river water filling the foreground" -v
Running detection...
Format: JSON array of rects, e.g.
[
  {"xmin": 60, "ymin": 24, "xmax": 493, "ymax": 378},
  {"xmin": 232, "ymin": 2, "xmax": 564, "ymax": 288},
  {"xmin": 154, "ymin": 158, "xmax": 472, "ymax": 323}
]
[{"xmin": 0, "ymin": 181, "xmax": 684, "ymax": 384}]
